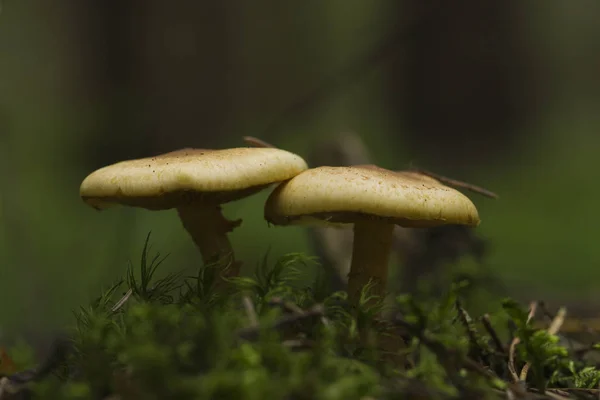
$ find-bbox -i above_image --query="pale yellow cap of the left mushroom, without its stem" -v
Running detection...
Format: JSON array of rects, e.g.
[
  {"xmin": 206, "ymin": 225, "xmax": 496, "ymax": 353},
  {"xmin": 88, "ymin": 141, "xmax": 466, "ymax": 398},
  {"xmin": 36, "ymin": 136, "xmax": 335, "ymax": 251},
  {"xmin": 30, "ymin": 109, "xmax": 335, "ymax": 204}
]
[{"xmin": 79, "ymin": 147, "xmax": 308, "ymax": 210}]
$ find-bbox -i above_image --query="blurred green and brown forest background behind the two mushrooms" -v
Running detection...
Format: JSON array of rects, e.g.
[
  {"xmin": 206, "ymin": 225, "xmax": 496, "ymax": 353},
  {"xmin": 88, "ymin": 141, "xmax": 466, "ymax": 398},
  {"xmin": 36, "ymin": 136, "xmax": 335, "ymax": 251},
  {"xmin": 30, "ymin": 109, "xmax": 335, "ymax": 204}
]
[{"xmin": 0, "ymin": 0, "xmax": 600, "ymax": 350}]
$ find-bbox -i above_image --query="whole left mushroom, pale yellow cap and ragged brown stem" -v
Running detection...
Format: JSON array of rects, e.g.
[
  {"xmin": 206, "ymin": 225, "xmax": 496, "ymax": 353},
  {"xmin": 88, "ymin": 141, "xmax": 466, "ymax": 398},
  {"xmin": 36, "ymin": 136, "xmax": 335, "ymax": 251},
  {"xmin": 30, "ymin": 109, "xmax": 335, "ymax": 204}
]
[{"xmin": 79, "ymin": 147, "xmax": 308, "ymax": 282}]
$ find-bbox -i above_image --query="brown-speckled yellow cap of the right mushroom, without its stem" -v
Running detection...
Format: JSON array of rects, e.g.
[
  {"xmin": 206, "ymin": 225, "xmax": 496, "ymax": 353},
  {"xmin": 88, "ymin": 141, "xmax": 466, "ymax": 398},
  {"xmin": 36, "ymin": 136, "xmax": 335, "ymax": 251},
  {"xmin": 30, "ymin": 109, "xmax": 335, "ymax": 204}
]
[{"xmin": 265, "ymin": 165, "xmax": 479, "ymax": 227}]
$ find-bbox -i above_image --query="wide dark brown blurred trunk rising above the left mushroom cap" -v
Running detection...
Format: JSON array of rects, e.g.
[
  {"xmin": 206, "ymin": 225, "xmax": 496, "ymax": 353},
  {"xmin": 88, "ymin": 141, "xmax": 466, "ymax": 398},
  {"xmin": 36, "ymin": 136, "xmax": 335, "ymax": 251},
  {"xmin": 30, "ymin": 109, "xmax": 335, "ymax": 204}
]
[{"xmin": 77, "ymin": 0, "xmax": 229, "ymax": 169}]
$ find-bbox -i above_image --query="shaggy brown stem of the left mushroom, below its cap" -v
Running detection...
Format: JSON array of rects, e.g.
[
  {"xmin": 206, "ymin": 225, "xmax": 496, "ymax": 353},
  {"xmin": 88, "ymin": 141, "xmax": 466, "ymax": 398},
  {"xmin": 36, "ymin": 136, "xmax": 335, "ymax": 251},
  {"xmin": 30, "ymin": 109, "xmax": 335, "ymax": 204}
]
[{"xmin": 177, "ymin": 205, "xmax": 242, "ymax": 285}]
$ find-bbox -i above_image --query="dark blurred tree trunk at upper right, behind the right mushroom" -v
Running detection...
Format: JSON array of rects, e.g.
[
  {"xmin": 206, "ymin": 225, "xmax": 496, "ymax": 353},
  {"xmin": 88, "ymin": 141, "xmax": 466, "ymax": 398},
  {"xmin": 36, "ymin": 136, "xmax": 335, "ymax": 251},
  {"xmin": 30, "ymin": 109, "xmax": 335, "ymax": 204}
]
[{"xmin": 388, "ymin": 0, "xmax": 536, "ymax": 170}]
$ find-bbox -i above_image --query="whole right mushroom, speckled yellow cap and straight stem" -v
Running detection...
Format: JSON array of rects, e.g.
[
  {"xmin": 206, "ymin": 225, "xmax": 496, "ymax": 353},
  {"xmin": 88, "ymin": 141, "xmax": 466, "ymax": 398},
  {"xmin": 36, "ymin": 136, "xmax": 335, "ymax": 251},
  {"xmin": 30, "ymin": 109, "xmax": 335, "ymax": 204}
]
[{"xmin": 265, "ymin": 165, "xmax": 480, "ymax": 305}]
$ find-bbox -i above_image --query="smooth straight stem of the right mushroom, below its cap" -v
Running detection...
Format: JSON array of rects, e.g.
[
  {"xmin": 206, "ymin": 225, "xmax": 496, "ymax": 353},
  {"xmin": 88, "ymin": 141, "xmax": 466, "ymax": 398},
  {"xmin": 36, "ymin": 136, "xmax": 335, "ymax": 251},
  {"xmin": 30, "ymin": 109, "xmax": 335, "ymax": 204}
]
[{"xmin": 348, "ymin": 221, "xmax": 394, "ymax": 306}]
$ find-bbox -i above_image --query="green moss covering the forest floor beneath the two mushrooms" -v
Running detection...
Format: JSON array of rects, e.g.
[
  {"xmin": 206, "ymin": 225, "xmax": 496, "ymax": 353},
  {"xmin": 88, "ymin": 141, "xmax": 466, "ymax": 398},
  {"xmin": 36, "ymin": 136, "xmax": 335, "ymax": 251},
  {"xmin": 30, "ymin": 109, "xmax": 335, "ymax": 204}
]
[{"xmin": 0, "ymin": 233, "xmax": 600, "ymax": 400}]
